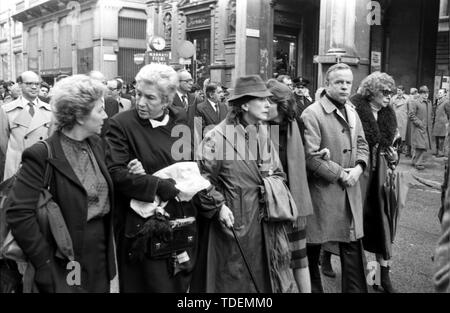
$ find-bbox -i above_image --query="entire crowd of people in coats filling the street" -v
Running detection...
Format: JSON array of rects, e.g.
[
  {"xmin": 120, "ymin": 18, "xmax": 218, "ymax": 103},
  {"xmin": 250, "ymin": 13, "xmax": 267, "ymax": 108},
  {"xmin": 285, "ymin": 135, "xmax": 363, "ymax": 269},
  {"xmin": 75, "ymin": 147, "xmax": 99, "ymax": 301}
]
[{"xmin": 0, "ymin": 63, "xmax": 450, "ymax": 293}]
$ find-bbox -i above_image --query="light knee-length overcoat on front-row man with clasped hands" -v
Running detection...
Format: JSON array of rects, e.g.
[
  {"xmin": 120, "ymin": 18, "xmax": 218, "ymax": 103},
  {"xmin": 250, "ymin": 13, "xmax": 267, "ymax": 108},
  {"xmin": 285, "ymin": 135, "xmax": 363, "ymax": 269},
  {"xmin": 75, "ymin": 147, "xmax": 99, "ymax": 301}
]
[{"xmin": 301, "ymin": 97, "xmax": 369, "ymax": 244}]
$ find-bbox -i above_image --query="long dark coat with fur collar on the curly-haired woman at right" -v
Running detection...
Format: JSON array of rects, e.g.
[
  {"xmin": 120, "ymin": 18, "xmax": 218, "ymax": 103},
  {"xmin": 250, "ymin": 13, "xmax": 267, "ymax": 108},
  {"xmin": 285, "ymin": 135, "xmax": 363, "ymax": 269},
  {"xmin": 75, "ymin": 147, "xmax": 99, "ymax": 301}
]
[{"xmin": 351, "ymin": 95, "xmax": 397, "ymax": 260}]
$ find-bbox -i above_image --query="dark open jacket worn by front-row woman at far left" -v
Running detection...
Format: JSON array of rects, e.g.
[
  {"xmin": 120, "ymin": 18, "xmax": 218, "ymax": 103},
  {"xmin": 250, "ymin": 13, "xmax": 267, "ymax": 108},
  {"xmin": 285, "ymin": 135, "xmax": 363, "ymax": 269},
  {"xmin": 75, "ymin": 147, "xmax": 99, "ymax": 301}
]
[{"xmin": 6, "ymin": 132, "xmax": 118, "ymax": 293}]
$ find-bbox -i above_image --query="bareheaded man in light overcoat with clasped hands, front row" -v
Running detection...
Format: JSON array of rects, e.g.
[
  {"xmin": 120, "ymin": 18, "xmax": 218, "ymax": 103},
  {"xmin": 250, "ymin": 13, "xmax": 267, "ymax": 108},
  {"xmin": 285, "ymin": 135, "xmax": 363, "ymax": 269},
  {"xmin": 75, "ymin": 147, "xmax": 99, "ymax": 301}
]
[{"xmin": 301, "ymin": 63, "xmax": 369, "ymax": 292}]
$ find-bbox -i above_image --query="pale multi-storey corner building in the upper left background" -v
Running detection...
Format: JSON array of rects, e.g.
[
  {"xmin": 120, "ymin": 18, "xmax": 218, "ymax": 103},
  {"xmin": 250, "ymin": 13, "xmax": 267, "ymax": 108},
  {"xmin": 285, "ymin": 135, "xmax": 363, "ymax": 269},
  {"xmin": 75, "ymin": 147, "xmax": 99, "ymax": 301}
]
[{"xmin": 12, "ymin": 0, "xmax": 147, "ymax": 83}]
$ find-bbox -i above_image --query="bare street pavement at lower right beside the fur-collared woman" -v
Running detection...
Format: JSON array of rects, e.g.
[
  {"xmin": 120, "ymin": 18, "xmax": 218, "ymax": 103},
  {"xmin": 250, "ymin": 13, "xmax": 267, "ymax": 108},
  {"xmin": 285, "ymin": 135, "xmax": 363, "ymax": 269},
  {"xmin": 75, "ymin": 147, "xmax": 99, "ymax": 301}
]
[{"xmin": 322, "ymin": 154, "xmax": 445, "ymax": 293}]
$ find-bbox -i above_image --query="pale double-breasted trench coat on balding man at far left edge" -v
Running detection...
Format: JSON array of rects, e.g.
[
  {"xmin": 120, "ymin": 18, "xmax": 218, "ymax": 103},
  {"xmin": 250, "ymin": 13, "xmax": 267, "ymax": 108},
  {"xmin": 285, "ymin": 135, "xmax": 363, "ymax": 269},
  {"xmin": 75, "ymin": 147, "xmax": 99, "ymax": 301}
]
[{"xmin": 0, "ymin": 97, "xmax": 52, "ymax": 180}]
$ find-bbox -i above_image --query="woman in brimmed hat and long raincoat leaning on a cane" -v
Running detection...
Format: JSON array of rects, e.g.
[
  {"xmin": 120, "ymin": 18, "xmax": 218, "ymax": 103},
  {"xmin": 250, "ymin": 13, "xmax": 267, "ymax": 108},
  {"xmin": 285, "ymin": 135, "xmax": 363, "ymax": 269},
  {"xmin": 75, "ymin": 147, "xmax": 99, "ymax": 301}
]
[{"xmin": 191, "ymin": 75, "xmax": 297, "ymax": 293}]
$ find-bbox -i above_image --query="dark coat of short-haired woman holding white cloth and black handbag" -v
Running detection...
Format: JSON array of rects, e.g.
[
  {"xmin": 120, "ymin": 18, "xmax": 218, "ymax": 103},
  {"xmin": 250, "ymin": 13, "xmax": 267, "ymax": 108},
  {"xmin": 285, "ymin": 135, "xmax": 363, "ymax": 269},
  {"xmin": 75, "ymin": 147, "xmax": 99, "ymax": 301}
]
[{"xmin": 106, "ymin": 110, "xmax": 197, "ymax": 292}]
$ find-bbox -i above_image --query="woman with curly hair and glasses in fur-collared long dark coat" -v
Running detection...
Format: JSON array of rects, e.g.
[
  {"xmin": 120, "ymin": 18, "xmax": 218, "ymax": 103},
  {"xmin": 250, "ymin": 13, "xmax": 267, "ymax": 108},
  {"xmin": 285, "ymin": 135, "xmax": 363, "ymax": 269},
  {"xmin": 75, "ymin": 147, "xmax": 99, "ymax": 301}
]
[{"xmin": 351, "ymin": 72, "xmax": 398, "ymax": 293}]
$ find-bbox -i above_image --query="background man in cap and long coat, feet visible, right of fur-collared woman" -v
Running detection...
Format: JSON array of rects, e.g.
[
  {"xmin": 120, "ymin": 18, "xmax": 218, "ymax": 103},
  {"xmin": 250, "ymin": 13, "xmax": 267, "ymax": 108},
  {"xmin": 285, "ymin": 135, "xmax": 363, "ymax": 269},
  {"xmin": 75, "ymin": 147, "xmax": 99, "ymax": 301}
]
[{"xmin": 409, "ymin": 86, "xmax": 433, "ymax": 170}]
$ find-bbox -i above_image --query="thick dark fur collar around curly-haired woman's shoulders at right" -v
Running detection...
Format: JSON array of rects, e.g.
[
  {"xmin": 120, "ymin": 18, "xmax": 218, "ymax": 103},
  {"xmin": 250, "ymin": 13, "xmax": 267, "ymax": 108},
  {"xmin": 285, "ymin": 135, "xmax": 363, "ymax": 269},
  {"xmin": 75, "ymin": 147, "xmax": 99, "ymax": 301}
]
[{"xmin": 350, "ymin": 94, "xmax": 397, "ymax": 148}]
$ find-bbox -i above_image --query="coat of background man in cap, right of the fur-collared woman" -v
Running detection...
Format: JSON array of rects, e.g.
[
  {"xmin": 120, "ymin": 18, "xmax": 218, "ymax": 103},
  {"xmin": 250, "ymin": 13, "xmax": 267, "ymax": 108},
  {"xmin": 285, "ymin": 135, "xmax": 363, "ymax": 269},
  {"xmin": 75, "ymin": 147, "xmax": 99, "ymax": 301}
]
[{"xmin": 409, "ymin": 98, "xmax": 433, "ymax": 150}]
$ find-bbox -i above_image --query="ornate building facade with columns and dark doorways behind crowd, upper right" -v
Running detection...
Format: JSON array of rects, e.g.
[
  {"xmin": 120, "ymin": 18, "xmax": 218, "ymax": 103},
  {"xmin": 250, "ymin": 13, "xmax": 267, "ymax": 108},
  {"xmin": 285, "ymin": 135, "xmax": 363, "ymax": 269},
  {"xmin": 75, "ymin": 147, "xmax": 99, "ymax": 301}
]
[{"xmin": 146, "ymin": 0, "xmax": 449, "ymax": 91}]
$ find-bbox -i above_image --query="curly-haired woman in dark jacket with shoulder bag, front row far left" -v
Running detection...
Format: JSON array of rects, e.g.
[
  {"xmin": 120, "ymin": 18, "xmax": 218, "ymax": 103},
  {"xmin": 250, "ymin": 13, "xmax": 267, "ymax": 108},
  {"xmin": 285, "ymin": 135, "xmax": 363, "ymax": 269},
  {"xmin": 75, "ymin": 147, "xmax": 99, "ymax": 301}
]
[{"xmin": 6, "ymin": 75, "xmax": 118, "ymax": 293}]
